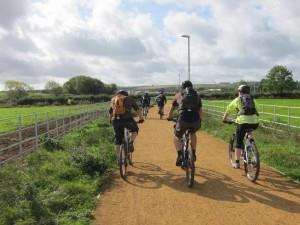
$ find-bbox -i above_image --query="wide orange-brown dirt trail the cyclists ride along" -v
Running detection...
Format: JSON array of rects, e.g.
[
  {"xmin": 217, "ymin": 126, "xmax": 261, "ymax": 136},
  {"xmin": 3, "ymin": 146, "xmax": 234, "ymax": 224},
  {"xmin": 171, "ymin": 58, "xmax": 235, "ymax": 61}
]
[{"xmin": 95, "ymin": 105, "xmax": 300, "ymax": 225}]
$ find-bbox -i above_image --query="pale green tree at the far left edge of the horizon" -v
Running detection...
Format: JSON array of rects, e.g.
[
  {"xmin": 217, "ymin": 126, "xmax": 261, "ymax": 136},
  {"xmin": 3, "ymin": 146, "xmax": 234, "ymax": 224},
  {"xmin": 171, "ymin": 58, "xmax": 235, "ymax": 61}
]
[{"xmin": 5, "ymin": 80, "xmax": 32, "ymax": 104}]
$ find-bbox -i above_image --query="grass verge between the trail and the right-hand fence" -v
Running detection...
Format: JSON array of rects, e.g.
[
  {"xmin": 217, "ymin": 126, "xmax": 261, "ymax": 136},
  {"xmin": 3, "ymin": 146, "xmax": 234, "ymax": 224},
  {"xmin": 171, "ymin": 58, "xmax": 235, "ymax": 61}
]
[{"xmin": 202, "ymin": 111, "xmax": 300, "ymax": 181}]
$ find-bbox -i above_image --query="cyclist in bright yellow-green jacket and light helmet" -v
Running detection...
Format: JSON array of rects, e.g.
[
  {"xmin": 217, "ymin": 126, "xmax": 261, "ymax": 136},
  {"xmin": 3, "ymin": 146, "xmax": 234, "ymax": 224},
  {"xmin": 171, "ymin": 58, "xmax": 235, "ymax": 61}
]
[{"xmin": 223, "ymin": 85, "xmax": 258, "ymax": 169}]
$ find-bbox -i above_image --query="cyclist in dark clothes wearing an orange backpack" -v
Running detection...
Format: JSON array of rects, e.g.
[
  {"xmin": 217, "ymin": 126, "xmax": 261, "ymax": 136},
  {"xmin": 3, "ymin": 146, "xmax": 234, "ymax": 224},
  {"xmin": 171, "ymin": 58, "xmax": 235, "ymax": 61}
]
[{"xmin": 109, "ymin": 90, "xmax": 144, "ymax": 161}]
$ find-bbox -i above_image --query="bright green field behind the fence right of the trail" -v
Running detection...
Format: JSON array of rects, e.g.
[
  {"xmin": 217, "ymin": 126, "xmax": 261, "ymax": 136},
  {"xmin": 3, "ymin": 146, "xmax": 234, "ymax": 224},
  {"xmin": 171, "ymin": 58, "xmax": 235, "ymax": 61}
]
[{"xmin": 203, "ymin": 99, "xmax": 300, "ymax": 127}]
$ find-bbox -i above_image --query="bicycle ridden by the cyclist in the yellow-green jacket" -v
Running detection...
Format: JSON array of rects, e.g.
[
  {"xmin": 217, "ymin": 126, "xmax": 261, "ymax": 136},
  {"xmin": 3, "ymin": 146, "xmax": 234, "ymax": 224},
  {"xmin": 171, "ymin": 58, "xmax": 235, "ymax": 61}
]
[{"xmin": 223, "ymin": 120, "xmax": 260, "ymax": 182}]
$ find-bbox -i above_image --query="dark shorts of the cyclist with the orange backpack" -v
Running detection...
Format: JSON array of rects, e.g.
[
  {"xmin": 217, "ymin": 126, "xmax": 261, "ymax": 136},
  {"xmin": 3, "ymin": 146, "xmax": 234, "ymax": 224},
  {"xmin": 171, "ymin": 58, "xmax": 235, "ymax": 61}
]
[{"xmin": 112, "ymin": 119, "xmax": 139, "ymax": 145}]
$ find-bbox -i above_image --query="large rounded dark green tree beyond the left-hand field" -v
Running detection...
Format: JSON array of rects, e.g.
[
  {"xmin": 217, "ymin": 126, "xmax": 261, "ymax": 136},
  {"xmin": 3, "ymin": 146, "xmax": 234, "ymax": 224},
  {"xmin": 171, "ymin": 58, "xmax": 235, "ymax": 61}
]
[{"xmin": 63, "ymin": 76, "xmax": 105, "ymax": 95}]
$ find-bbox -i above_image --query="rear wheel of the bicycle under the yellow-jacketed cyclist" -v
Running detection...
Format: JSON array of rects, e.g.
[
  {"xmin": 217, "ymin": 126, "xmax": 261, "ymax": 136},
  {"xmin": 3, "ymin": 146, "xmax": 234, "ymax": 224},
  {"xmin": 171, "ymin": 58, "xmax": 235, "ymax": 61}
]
[{"xmin": 244, "ymin": 141, "xmax": 260, "ymax": 182}]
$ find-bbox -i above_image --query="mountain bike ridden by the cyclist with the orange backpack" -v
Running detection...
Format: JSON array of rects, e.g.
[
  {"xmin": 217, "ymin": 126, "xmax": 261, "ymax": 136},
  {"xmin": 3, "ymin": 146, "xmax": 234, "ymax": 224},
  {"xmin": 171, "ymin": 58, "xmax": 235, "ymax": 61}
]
[{"xmin": 118, "ymin": 128, "xmax": 133, "ymax": 179}]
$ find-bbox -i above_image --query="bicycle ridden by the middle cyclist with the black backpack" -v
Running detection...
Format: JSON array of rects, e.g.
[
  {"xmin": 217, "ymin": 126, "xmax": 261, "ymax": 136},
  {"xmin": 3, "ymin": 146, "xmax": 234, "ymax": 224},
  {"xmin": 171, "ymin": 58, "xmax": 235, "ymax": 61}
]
[{"xmin": 168, "ymin": 119, "xmax": 195, "ymax": 188}]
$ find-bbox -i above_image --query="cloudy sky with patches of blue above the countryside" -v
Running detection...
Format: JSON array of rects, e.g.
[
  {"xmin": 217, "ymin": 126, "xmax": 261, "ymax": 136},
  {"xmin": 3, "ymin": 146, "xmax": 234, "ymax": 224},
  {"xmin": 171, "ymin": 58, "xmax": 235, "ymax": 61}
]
[{"xmin": 0, "ymin": 0, "xmax": 300, "ymax": 90}]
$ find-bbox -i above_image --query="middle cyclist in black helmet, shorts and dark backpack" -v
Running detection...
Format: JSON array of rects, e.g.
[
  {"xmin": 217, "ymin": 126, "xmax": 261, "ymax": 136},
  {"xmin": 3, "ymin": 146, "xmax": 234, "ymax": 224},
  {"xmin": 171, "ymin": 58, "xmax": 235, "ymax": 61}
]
[{"xmin": 168, "ymin": 80, "xmax": 202, "ymax": 166}]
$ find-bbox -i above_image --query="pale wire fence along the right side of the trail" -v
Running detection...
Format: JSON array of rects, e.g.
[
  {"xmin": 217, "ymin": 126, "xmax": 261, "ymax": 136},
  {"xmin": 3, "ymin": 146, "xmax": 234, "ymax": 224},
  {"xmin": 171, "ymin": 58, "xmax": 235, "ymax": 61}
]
[{"xmin": 203, "ymin": 101, "xmax": 300, "ymax": 132}]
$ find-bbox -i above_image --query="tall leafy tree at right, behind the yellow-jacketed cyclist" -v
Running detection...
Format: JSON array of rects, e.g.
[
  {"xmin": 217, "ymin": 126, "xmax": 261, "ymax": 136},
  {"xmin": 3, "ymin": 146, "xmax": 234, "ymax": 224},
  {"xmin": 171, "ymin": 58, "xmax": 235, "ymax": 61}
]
[{"xmin": 260, "ymin": 65, "xmax": 297, "ymax": 94}]
